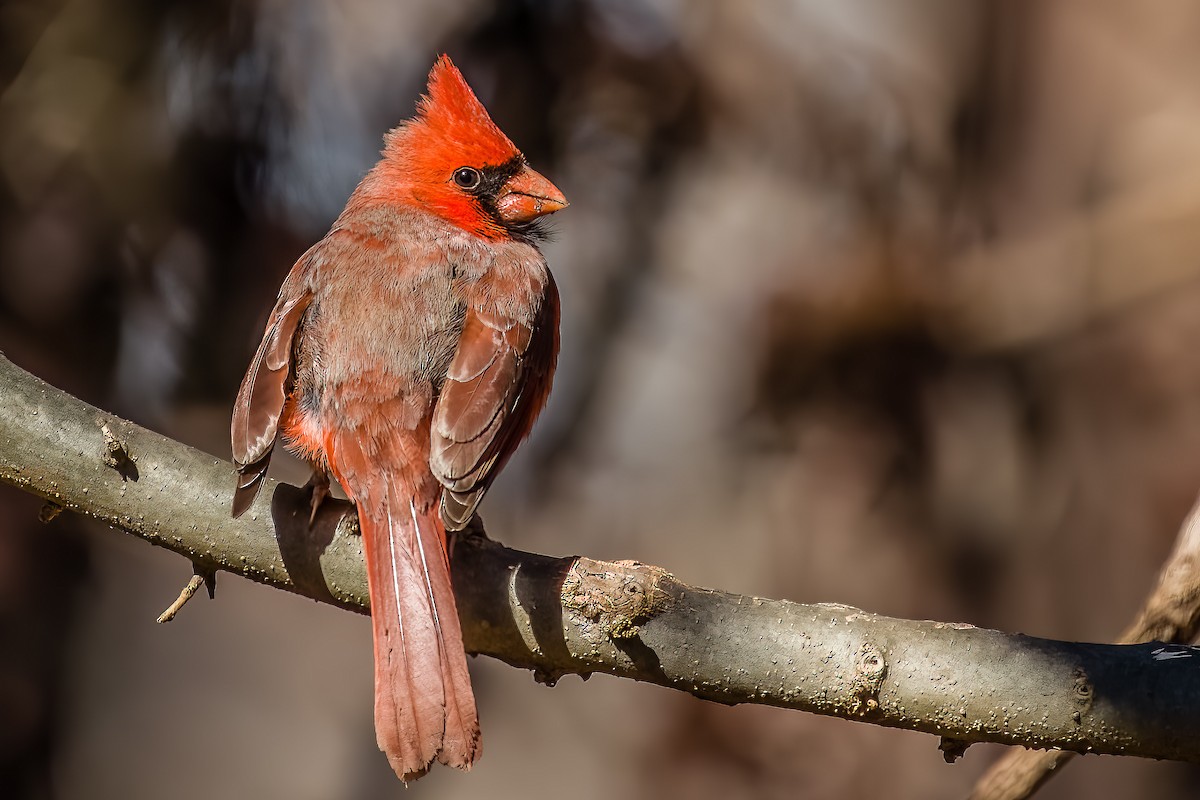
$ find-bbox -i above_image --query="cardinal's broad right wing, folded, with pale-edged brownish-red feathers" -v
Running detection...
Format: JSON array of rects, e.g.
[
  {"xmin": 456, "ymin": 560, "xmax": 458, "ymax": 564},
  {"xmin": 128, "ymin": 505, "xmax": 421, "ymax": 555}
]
[{"xmin": 430, "ymin": 278, "xmax": 558, "ymax": 530}]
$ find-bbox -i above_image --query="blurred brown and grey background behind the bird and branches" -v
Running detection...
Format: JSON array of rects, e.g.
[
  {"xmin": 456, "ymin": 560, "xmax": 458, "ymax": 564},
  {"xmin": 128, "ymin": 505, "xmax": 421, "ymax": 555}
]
[{"xmin": 0, "ymin": 0, "xmax": 1200, "ymax": 800}]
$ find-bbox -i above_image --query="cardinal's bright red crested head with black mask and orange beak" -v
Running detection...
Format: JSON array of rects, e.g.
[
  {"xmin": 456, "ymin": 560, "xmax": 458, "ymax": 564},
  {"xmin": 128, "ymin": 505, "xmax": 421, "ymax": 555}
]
[{"xmin": 369, "ymin": 55, "xmax": 566, "ymax": 239}]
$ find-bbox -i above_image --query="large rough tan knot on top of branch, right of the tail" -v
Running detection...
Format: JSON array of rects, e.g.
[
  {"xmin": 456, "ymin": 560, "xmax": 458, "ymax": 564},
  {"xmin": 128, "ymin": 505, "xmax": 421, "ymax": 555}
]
[{"xmin": 562, "ymin": 558, "xmax": 671, "ymax": 639}]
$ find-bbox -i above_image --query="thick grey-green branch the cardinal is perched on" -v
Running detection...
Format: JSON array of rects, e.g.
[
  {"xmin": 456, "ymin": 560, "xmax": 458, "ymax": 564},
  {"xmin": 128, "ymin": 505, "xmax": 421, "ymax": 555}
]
[{"xmin": 0, "ymin": 356, "xmax": 1200, "ymax": 760}]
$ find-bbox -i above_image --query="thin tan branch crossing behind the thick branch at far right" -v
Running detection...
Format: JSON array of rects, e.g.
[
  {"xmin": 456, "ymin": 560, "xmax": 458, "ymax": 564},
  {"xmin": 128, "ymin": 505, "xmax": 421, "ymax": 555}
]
[{"xmin": 971, "ymin": 500, "xmax": 1200, "ymax": 800}]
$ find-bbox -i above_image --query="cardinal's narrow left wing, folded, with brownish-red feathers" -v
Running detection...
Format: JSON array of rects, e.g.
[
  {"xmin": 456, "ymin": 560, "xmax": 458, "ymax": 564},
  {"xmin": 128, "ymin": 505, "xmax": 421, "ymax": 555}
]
[{"xmin": 230, "ymin": 276, "xmax": 312, "ymax": 517}]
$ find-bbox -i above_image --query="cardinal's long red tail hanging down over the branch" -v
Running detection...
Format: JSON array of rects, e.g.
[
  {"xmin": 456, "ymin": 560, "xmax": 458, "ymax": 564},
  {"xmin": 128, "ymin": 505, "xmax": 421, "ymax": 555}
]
[{"xmin": 355, "ymin": 476, "xmax": 480, "ymax": 780}]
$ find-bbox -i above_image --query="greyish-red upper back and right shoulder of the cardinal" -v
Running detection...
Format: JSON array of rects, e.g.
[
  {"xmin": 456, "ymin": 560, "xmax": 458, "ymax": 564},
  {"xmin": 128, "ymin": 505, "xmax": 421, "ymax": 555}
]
[{"xmin": 288, "ymin": 203, "xmax": 548, "ymax": 427}]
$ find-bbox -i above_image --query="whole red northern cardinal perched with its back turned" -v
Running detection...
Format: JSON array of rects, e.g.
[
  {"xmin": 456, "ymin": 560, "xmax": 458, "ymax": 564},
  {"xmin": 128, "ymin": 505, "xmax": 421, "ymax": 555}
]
[{"xmin": 232, "ymin": 55, "xmax": 566, "ymax": 780}]
